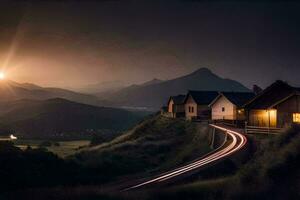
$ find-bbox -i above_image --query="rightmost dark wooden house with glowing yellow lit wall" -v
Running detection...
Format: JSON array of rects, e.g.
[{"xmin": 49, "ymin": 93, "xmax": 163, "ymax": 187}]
[{"xmin": 244, "ymin": 81, "xmax": 300, "ymax": 128}]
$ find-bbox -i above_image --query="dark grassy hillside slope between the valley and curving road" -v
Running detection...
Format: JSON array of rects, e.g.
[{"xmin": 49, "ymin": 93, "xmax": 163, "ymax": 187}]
[{"xmin": 75, "ymin": 116, "xmax": 211, "ymax": 179}]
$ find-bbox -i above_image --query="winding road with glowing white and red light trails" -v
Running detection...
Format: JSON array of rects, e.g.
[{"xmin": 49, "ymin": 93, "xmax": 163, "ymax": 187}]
[{"xmin": 123, "ymin": 124, "xmax": 247, "ymax": 191}]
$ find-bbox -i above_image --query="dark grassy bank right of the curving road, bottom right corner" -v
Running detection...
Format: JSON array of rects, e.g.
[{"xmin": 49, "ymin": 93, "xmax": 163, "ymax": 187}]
[{"xmin": 144, "ymin": 126, "xmax": 300, "ymax": 200}]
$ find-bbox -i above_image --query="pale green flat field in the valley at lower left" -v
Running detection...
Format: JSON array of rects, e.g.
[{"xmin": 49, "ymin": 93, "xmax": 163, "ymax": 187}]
[{"xmin": 14, "ymin": 139, "xmax": 90, "ymax": 158}]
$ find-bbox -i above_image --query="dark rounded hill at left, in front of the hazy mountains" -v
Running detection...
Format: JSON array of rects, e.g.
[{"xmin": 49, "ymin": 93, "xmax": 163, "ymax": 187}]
[{"xmin": 0, "ymin": 98, "xmax": 142, "ymax": 137}]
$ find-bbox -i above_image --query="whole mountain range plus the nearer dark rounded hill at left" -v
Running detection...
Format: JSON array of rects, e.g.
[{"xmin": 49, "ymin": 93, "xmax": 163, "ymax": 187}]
[{"xmin": 0, "ymin": 68, "xmax": 249, "ymax": 137}]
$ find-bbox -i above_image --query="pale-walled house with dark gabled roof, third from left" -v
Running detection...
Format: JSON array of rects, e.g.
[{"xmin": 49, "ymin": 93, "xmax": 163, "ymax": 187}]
[{"xmin": 209, "ymin": 92, "xmax": 255, "ymax": 123}]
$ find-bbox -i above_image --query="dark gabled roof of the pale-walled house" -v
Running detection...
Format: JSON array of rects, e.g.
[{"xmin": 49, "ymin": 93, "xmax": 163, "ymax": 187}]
[{"xmin": 209, "ymin": 92, "xmax": 255, "ymax": 107}]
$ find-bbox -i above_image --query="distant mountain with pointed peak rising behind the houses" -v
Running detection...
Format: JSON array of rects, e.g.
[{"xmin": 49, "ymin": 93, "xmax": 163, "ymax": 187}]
[{"xmin": 98, "ymin": 68, "xmax": 249, "ymax": 109}]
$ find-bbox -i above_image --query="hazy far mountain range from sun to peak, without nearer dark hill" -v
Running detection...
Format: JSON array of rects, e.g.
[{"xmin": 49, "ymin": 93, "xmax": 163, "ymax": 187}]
[{"xmin": 0, "ymin": 68, "xmax": 249, "ymax": 110}]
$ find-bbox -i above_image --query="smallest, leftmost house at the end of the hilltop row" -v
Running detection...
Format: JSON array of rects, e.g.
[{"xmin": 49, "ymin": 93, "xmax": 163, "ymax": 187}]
[{"xmin": 167, "ymin": 95, "xmax": 185, "ymax": 118}]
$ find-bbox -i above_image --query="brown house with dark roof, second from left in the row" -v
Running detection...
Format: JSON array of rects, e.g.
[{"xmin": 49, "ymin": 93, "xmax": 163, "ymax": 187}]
[{"xmin": 184, "ymin": 91, "xmax": 219, "ymax": 120}]
